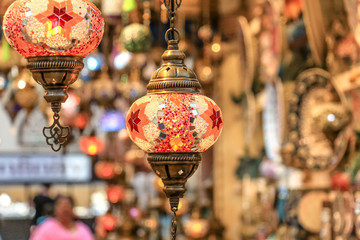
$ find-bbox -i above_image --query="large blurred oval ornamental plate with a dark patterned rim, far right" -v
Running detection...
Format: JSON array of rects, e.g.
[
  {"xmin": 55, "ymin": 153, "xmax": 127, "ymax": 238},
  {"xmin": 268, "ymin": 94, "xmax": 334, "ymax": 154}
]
[{"xmin": 282, "ymin": 68, "xmax": 351, "ymax": 170}]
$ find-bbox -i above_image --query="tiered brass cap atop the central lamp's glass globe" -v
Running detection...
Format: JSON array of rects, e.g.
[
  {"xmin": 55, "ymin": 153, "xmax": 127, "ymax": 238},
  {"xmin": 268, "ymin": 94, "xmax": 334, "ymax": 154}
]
[{"xmin": 147, "ymin": 40, "xmax": 201, "ymax": 94}]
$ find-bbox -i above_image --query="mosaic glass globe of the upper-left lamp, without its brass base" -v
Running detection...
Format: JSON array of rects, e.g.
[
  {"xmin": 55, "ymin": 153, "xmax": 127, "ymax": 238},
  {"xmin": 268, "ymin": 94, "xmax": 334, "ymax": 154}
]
[{"xmin": 3, "ymin": 0, "xmax": 104, "ymax": 57}]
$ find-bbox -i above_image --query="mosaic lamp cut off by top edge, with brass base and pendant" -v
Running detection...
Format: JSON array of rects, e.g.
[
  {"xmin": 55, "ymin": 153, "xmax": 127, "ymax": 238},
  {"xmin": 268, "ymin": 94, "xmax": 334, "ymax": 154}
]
[{"xmin": 3, "ymin": 0, "xmax": 104, "ymax": 151}]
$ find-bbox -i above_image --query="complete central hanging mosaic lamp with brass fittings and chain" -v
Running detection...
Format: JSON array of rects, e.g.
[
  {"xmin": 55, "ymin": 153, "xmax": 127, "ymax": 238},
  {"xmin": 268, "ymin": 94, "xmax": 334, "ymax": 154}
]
[{"xmin": 126, "ymin": 0, "xmax": 223, "ymax": 239}]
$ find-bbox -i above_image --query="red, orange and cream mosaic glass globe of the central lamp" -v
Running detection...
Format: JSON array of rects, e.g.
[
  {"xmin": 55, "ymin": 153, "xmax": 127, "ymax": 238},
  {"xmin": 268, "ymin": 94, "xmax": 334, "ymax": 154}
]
[{"xmin": 127, "ymin": 93, "xmax": 223, "ymax": 152}]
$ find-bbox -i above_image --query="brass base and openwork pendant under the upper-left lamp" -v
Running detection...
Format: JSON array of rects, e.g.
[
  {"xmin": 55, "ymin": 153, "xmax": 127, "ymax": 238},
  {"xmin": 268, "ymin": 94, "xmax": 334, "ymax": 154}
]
[{"xmin": 27, "ymin": 56, "xmax": 84, "ymax": 152}]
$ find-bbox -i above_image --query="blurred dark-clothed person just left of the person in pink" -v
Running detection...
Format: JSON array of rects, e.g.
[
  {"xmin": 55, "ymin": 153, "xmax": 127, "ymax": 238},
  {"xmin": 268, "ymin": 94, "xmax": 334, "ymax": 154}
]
[{"xmin": 30, "ymin": 183, "xmax": 54, "ymax": 232}]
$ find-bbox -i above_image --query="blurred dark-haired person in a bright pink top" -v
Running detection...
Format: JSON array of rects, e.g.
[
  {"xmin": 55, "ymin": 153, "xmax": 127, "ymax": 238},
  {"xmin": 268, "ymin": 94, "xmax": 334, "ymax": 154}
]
[{"xmin": 30, "ymin": 195, "xmax": 94, "ymax": 240}]
